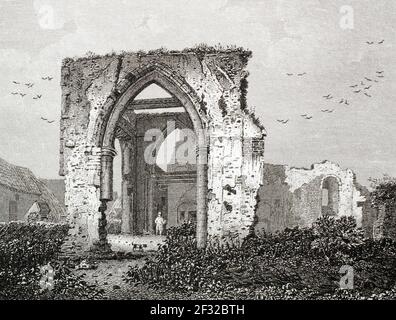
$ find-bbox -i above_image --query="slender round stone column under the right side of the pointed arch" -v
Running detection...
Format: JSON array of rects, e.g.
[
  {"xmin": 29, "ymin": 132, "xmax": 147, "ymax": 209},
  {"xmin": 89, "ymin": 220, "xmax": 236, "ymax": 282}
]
[{"xmin": 197, "ymin": 143, "xmax": 208, "ymax": 249}]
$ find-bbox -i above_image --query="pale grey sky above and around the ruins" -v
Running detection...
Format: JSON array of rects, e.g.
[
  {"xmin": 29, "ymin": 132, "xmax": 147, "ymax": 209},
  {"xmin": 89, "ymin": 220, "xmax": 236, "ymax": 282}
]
[{"xmin": 0, "ymin": 0, "xmax": 396, "ymax": 184}]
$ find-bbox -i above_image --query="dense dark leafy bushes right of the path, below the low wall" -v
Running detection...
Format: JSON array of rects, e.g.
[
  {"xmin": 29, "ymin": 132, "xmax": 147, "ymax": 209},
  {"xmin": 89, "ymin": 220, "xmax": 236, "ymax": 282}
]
[{"xmin": 125, "ymin": 217, "xmax": 396, "ymax": 299}]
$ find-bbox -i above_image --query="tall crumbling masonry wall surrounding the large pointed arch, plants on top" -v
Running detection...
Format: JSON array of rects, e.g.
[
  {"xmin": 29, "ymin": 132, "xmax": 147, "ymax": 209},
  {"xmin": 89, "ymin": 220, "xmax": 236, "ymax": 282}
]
[{"xmin": 60, "ymin": 48, "xmax": 265, "ymax": 251}]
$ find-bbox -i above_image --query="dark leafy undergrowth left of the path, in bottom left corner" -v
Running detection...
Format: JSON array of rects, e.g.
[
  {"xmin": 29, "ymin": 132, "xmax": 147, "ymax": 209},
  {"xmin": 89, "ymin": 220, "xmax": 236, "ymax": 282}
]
[{"xmin": 0, "ymin": 222, "xmax": 100, "ymax": 299}]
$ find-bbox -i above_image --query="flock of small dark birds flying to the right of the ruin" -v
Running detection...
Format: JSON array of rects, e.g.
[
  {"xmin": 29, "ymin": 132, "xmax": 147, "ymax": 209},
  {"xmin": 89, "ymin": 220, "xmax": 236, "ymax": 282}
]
[{"xmin": 276, "ymin": 40, "xmax": 385, "ymax": 125}]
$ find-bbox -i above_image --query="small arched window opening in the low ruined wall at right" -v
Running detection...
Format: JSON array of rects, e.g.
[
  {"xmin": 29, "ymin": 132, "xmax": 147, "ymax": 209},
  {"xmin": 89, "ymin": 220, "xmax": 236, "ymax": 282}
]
[{"xmin": 321, "ymin": 177, "xmax": 340, "ymax": 216}]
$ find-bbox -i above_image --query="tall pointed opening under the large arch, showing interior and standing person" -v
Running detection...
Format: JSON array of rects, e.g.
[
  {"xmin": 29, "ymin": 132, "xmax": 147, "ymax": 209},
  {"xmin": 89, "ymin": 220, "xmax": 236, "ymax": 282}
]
[{"xmin": 103, "ymin": 84, "xmax": 201, "ymax": 236}]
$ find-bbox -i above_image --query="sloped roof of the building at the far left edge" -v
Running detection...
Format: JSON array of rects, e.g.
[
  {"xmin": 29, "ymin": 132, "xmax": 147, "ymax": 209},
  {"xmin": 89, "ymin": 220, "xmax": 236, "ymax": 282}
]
[{"xmin": 0, "ymin": 158, "xmax": 41, "ymax": 195}]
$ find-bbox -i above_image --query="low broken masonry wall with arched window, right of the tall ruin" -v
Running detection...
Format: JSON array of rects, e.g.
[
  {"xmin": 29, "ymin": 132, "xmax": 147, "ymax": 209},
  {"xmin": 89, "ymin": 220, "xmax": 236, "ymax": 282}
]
[{"xmin": 255, "ymin": 161, "xmax": 366, "ymax": 232}]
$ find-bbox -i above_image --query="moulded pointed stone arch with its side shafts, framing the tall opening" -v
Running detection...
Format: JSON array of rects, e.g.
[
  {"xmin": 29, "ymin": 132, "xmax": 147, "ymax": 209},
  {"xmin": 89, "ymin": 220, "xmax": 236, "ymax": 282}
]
[{"xmin": 99, "ymin": 64, "xmax": 208, "ymax": 248}]
